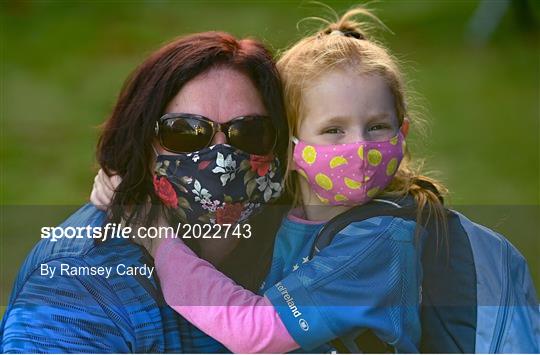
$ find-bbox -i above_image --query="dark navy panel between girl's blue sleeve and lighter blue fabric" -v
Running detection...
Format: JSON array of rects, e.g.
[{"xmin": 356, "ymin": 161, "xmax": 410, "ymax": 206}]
[{"xmin": 420, "ymin": 214, "xmax": 477, "ymax": 353}]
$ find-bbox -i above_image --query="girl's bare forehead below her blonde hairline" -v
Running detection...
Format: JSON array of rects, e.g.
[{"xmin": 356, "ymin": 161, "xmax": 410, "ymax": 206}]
[{"xmin": 302, "ymin": 68, "xmax": 395, "ymax": 123}]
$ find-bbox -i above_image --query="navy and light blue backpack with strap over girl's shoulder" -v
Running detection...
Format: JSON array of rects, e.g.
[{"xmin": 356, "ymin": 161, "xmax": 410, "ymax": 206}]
[{"xmin": 310, "ymin": 192, "xmax": 540, "ymax": 353}]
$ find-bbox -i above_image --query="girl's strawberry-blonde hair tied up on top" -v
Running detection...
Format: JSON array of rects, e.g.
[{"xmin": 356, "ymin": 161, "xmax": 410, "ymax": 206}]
[{"xmin": 277, "ymin": 7, "xmax": 447, "ymax": 239}]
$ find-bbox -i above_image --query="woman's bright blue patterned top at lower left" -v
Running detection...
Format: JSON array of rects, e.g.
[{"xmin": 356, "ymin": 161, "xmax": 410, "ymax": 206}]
[{"xmin": 0, "ymin": 204, "xmax": 229, "ymax": 353}]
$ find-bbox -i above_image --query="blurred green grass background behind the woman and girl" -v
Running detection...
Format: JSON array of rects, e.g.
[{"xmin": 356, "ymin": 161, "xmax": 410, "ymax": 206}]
[{"xmin": 0, "ymin": 0, "xmax": 540, "ymax": 318}]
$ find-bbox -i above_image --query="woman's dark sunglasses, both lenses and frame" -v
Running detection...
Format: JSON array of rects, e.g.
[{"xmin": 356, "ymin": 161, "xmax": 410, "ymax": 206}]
[{"xmin": 156, "ymin": 113, "xmax": 277, "ymax": 155}]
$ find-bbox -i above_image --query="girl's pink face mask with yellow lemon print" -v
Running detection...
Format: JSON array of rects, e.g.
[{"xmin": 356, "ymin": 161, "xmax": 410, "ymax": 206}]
[{"xmin": 293, "ymin": 131, "xmax": 405, "ymax": 205}]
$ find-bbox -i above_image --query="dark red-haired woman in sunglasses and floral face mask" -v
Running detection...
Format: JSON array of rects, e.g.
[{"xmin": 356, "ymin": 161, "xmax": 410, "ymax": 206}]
[{"xmin": 0, "ymin": 32, "xmax": 288, "ymax": 353}]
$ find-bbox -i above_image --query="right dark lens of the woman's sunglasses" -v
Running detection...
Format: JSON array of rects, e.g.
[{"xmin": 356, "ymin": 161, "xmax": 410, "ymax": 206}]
[{"xmin": 229, "ymin": 117, "xmax": 277, "ymax": 155}]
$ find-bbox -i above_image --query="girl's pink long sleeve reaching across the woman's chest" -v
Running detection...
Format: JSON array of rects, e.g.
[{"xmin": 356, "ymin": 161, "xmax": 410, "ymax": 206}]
[{"xmin": 155, "ymin": 238, "xmax": 299, "ymax": 353}]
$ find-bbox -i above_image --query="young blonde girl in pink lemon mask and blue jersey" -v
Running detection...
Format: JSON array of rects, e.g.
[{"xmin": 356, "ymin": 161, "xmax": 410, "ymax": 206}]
[{"xmin": 94, "ymin": 9, "xmax": 444, "ymax": 353}]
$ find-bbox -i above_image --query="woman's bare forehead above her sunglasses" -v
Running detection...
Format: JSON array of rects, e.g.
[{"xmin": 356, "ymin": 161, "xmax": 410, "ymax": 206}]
[{"xmin": 165, "ymin": 66, "xmax": 267, "ymax": 123}]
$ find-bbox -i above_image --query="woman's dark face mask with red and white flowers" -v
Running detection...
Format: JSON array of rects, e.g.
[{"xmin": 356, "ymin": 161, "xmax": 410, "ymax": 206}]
[{"xmin": 154, "ymin": 144, "xmax": 283, "ymax": 224}]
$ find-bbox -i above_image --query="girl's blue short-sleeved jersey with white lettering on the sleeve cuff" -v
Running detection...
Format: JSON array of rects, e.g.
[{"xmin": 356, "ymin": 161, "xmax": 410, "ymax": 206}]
[{"xmin": 261, "ymin": 213, "xmax": 422, "ymax": 352}]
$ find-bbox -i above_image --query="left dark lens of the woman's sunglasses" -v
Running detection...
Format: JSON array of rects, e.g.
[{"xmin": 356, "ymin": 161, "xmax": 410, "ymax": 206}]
[{"xmin": 159, "ymin": 117, "xmax": 213, "ymax": 153}]
